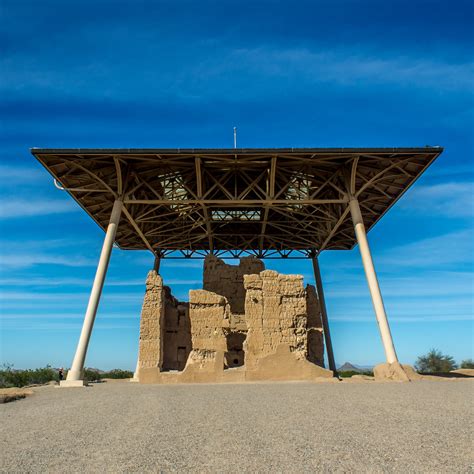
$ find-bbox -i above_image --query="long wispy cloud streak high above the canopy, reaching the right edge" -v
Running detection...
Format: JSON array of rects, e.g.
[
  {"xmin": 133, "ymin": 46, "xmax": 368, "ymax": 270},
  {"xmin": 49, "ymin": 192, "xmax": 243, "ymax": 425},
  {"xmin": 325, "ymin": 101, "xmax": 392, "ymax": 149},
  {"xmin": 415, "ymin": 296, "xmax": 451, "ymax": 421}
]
[{"xmin": 192, "ymin": 46, "xmax": 474, "ymax": 97}]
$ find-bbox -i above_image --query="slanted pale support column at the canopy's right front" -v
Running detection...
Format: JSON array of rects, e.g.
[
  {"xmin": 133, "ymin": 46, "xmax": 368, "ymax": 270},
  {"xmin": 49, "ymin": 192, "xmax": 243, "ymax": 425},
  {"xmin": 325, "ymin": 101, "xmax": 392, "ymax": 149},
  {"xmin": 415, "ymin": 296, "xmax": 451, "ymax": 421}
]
[{"xmin": 349, "ymin": 196, "xmax": 398, "ymax": 364}]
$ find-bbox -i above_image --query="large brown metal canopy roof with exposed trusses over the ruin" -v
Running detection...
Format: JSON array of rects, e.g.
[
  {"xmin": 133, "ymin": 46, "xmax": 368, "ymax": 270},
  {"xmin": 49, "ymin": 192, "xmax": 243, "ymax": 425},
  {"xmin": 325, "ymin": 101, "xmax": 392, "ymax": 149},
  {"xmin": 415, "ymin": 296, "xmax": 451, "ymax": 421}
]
[{"xmin": 31, "ymin": 147, "xmax": 443, "ymax": 258}]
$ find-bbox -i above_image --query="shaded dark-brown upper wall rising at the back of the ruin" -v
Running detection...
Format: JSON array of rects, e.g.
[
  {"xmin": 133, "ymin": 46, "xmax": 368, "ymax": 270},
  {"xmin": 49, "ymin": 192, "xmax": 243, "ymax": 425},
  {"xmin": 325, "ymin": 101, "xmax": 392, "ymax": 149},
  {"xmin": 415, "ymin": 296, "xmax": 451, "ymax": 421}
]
[{"xmin": 203, "ymin": 255, "xmax": 265, "ymax": 314}]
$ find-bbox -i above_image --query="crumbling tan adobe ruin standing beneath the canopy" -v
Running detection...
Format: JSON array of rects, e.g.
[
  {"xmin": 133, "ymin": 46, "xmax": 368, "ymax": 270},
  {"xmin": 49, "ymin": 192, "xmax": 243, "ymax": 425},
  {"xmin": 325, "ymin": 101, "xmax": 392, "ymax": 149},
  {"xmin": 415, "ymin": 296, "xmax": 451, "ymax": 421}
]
[{"xmin": 136, "ymin": 255, "xmax": 333, "ymax": 383}]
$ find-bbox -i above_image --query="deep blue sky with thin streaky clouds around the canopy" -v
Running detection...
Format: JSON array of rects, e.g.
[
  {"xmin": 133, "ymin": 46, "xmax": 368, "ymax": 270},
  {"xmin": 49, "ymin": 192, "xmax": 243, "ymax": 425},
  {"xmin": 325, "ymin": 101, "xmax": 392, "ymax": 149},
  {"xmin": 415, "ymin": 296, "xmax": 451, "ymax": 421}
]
[{"xmin": 0, "ymin": 0, "xmax": 474, "ymax": 369}]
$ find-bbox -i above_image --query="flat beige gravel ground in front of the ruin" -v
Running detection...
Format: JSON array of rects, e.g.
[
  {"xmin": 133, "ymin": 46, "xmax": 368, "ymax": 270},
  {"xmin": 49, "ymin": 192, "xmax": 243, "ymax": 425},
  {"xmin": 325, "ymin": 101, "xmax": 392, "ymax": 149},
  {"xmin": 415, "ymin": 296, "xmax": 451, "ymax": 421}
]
[{"xmin": 0, "ymin": 380, "xmax": 474, "ymax": 473}]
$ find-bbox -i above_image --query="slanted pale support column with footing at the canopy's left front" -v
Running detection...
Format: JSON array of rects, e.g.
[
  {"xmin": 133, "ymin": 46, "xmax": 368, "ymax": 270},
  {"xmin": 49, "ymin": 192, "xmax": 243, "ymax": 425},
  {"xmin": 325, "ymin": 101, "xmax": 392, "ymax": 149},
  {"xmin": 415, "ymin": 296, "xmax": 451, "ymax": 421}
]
[{"xmin": 60, "ymin": 199, "xmax": 123, "ymax": 387}]
